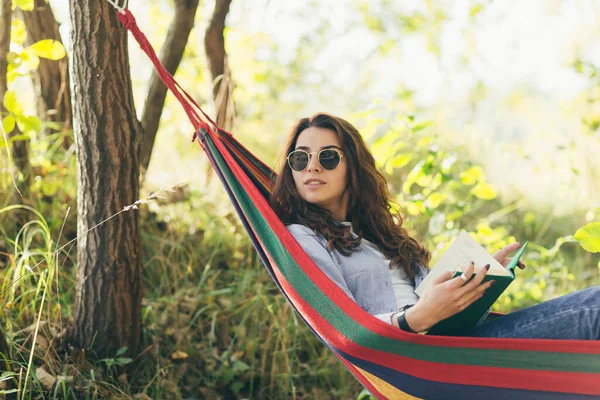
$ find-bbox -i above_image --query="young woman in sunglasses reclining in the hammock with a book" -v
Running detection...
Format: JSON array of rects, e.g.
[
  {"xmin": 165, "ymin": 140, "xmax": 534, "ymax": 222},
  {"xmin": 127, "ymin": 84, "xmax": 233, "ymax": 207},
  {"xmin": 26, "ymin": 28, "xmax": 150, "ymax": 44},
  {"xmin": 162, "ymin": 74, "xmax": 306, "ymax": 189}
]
[{"xmin": 271, "ymin": 114, "xmax": 600, "ymax": 340}]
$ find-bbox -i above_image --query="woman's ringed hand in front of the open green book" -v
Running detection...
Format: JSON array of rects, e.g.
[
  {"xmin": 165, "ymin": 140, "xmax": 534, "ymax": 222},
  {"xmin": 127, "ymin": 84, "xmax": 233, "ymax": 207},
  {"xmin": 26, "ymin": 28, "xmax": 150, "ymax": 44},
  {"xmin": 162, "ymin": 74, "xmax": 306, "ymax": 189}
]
[{"xmin": 404, "ymin": 263, "xmax": 495, "ymax": 332}]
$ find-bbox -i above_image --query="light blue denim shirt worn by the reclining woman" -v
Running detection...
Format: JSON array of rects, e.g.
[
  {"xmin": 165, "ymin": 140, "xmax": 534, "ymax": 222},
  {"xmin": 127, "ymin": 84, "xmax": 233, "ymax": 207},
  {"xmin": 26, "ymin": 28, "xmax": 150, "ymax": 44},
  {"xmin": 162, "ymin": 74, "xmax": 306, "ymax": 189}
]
[{"xmin": 287, "ymin": 222, "xmax": 427, "ymax": 324}]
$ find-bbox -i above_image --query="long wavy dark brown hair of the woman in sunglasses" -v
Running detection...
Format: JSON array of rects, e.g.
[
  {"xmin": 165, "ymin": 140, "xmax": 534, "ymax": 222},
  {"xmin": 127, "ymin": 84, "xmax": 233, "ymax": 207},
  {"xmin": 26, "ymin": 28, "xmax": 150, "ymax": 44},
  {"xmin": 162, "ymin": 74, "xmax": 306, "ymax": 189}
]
[{"xmin": 271, "ymin": 113, "xmax": 431, "ymax": 277}]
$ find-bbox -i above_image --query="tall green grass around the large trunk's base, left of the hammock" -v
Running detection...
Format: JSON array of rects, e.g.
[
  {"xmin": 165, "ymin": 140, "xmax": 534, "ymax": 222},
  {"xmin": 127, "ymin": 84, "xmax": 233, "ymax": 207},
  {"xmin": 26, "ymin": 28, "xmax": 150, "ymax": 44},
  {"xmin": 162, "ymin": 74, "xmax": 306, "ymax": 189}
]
[{"xmin": 0, "ymin": 183, "xmax": 361, "ymax": 399}]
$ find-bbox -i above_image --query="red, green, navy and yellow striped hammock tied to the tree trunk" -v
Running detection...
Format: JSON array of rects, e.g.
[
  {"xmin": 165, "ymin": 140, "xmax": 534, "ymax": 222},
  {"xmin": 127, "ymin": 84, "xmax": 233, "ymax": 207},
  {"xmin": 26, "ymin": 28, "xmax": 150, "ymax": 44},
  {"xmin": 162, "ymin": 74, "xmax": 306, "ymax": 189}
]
[{"xmin": 119, "ymin": 9, "xmax": 600, "ymax": 400}]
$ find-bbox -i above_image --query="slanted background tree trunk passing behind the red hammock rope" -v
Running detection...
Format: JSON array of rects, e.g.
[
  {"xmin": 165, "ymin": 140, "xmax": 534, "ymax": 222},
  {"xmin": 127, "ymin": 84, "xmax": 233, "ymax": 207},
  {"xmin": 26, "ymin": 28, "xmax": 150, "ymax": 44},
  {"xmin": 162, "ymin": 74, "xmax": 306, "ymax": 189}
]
[{"xmin": 141, "ymin": 0, "xmax": 199, "ymax": 174}]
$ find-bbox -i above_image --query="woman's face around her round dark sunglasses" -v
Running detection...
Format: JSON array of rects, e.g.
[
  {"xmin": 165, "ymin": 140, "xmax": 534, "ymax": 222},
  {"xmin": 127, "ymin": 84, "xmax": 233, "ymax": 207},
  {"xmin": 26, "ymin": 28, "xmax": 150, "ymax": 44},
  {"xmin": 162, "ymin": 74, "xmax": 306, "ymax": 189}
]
[{"xmin": 288, "ymin": 127, "xmax": 348, "ymax": 221}]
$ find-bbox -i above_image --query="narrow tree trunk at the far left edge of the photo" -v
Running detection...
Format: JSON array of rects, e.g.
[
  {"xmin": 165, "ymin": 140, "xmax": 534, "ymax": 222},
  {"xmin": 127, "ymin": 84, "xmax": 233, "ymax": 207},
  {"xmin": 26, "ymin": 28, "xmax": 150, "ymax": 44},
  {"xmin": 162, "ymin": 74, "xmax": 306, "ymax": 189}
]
[{"xmin": 0, "ymin": 0, "xmax": 31, "ymax": 188}]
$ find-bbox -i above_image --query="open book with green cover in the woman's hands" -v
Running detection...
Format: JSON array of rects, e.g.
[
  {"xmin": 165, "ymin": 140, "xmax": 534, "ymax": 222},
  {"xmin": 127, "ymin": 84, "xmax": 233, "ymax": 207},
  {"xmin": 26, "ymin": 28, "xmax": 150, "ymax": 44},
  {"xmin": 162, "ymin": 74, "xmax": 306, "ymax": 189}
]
[{"xmin": 415, "ymin": 231, "xmax": 528, "ymax": 335}]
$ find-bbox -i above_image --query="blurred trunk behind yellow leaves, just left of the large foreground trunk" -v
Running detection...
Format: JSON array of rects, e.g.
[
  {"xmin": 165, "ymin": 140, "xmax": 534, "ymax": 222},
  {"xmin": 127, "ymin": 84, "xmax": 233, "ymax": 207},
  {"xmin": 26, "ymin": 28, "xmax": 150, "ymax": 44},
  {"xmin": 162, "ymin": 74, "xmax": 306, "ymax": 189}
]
[{"xmin": 21, "ymin": 0, "xmax": 72, "ymax": 144}]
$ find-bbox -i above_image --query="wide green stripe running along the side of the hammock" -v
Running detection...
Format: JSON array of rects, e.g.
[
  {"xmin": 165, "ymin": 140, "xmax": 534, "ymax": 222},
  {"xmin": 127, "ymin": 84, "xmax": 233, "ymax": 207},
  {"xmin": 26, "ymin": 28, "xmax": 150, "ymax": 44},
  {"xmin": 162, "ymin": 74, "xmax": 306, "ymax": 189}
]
[{"xmin": 203, "ymin": 132, "xmax": 600, "ymax": 373}]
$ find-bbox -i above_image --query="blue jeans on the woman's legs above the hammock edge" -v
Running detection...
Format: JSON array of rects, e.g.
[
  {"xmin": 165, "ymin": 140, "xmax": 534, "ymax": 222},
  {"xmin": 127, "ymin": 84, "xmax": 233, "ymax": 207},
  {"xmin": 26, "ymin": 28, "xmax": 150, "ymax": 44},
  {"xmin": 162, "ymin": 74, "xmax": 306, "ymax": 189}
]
[{"xmin": 461, "ymin": 286, "xmax": 600, "ymax": 340}]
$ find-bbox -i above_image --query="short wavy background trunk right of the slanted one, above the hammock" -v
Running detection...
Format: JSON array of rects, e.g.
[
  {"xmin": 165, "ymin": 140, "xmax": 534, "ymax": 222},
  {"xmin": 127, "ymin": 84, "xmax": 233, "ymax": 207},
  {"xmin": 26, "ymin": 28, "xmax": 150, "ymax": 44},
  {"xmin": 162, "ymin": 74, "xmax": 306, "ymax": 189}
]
[{"xmin": 204, "ymin": 0, "xmax": 235, "ymax": 131}]
